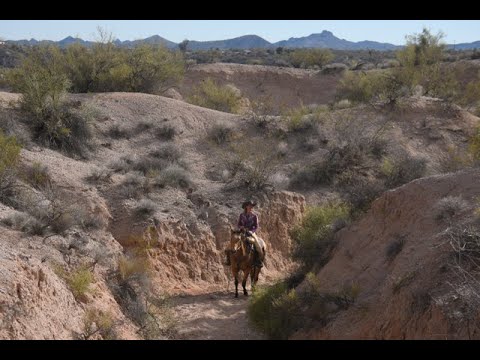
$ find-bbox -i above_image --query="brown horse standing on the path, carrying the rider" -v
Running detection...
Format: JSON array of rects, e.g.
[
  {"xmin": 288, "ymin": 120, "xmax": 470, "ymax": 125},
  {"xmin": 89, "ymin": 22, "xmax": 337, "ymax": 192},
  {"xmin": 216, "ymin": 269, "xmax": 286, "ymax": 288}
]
[{"xmin": 230, "ymin": 229, "xmax": 265, "ymax": 297}]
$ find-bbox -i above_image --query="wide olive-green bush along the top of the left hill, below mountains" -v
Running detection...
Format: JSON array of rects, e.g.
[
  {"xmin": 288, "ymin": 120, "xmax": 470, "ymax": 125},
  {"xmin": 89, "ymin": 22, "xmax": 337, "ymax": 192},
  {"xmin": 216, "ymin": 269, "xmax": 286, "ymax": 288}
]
[{"xmin": 63, "ymin": 40, "xmax": 185, "ymax": 94}]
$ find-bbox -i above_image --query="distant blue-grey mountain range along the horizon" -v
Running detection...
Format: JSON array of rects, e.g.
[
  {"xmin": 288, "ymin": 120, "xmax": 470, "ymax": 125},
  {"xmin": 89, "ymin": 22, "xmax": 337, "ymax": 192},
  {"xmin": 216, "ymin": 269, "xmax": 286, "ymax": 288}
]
[{"xmin": 7, "ymin": 30, "xmax": 480, "ymax": 50}]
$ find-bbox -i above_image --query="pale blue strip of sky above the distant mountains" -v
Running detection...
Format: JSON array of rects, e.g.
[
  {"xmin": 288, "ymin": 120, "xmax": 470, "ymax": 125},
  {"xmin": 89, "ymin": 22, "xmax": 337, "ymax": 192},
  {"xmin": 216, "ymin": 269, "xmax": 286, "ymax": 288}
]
[{"xmin": 0, "ymin": 20, "xmax": 480, "ymax": 45}]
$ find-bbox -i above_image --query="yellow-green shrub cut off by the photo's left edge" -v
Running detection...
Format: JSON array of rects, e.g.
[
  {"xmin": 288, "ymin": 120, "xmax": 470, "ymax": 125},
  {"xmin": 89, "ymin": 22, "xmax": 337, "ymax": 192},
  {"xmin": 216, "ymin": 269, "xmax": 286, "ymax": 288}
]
[{"xmin": 0, "ymin": 130, "xmax": 21, "ymax": 201}]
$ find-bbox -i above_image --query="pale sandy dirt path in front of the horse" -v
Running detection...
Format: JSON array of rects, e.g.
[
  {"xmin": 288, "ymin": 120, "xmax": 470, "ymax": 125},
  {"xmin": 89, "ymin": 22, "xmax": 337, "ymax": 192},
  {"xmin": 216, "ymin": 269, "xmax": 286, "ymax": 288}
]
[{"xmin": 173, "ymin": 291, "xmax": 263, "ymax": 340}]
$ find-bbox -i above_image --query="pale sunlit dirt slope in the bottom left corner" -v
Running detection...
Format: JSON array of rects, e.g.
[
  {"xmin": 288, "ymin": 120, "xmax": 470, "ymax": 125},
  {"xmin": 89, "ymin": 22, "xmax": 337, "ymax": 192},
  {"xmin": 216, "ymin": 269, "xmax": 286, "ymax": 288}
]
[{"xmin": 0, "ymin": 238, "xmax": 83, "ymax": 339}]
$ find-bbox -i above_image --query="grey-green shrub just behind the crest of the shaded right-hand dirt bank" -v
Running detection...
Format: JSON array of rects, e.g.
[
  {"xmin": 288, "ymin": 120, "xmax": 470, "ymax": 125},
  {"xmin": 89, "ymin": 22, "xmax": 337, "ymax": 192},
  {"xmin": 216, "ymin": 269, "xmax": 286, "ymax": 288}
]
[{"xmin": 381, "ymin": 154, "xmax": 427, "ymax": 189}]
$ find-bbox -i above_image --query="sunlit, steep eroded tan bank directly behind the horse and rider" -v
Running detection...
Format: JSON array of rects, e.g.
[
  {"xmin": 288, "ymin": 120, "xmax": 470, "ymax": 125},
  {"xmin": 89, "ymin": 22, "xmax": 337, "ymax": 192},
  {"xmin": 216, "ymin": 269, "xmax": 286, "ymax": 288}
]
[{"xmin": 112, "ymin": 191, "xmax": 305, "ymax": 293}]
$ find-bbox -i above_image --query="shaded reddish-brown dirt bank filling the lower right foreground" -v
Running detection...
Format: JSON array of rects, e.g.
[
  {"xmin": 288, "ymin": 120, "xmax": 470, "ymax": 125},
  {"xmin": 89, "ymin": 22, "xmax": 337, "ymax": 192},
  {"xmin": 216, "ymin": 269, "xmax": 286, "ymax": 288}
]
[{"xmin": 294, "ymin": 169, "xmax": 480, "ymax": 339}]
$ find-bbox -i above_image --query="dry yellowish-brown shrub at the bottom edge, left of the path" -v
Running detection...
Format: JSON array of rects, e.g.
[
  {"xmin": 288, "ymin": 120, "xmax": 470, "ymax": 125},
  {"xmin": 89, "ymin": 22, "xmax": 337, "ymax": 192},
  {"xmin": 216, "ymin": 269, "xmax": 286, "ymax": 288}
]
[{"xmin": 80, "ymin": 308, "xmax": 118, "ymax": 340}]
